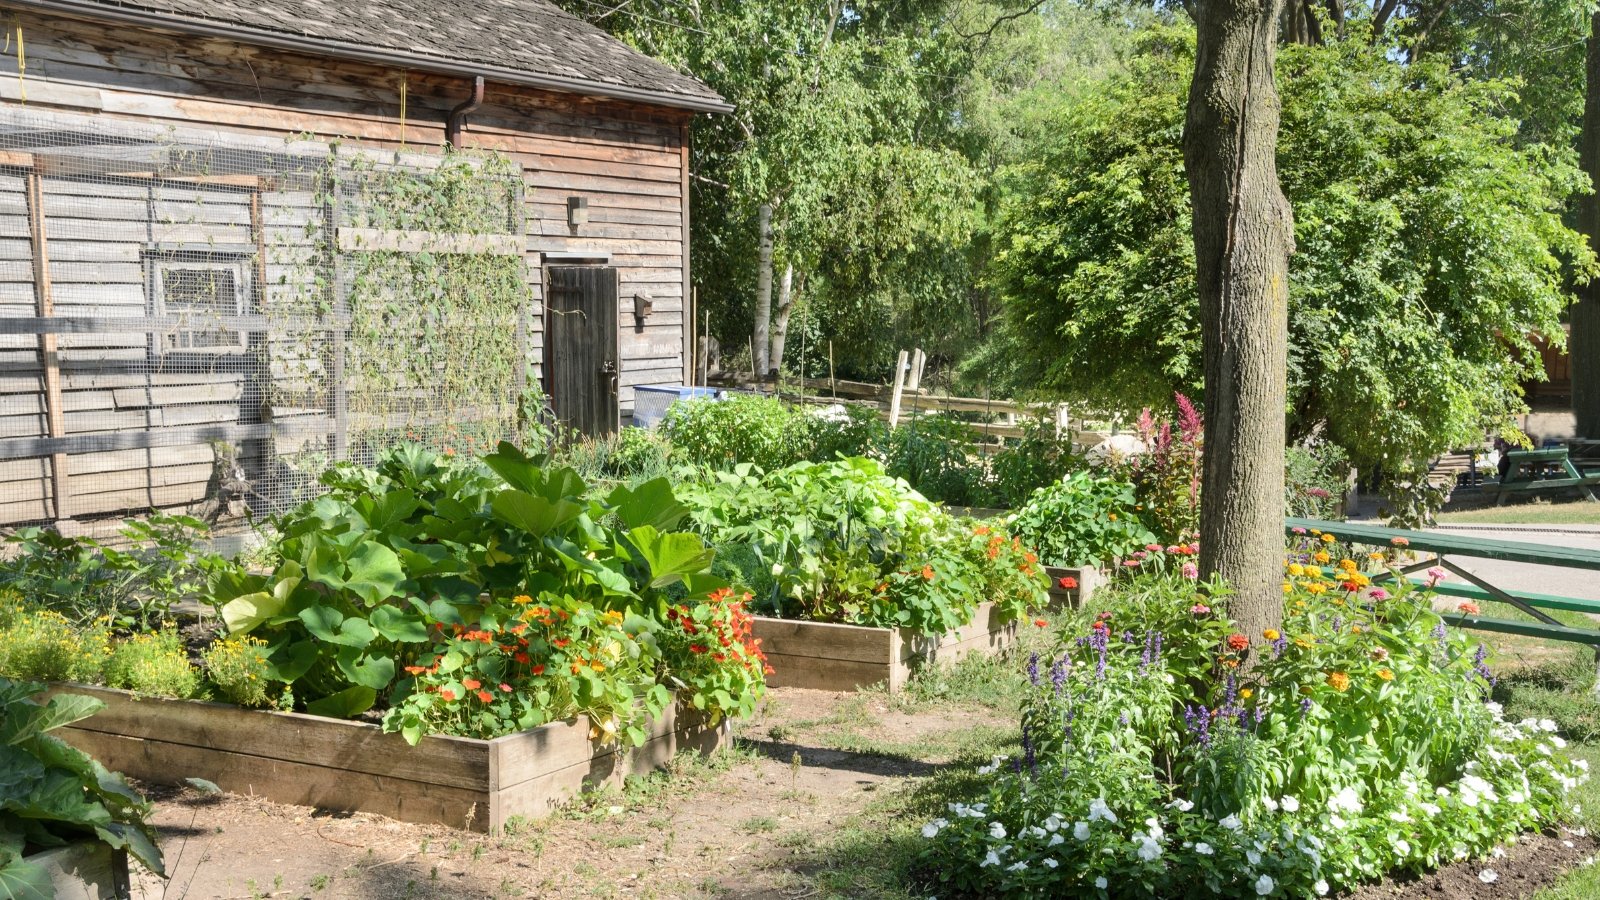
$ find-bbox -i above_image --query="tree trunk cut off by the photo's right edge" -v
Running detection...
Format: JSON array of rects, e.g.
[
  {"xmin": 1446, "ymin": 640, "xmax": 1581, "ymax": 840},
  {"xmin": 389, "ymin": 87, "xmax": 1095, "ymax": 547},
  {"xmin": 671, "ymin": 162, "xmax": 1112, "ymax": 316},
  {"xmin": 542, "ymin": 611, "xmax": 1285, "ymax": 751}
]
[{"xmin": 1566, "ymin": 13, "xmax": 1600, "ymax": 440}]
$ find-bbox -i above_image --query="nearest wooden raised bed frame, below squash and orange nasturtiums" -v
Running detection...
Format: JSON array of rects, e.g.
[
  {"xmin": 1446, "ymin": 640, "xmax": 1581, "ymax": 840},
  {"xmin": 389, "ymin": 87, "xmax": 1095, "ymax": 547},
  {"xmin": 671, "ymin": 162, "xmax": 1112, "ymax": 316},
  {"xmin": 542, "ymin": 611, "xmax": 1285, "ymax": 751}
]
[{"xmin": 53, "ymin": 684, "xmax": 730, "ymax": 833}]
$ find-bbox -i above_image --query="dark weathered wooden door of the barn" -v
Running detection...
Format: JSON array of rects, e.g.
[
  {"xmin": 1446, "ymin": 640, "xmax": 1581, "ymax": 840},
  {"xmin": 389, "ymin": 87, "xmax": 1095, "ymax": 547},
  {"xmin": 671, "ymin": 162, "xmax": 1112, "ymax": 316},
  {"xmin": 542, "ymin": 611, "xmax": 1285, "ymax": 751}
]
[{"xmin": 544, "ymin": 266, "xmax": 621, "ymax": 437}]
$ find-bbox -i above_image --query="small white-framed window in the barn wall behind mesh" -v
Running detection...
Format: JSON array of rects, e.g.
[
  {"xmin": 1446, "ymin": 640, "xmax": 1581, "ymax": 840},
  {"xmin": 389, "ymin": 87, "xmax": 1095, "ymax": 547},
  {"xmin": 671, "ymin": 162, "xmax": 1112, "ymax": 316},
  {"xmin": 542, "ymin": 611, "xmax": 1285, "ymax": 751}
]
[{"xmin": 149, "ymin": 251, "xmax": 250, "ymax": 354}]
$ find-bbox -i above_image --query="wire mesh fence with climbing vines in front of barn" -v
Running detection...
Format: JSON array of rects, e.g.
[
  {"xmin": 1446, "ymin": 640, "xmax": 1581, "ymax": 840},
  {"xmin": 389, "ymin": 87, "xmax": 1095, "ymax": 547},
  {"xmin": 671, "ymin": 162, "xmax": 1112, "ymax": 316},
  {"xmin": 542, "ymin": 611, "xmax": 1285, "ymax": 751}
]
[{"xmin": 0, "ymin": 109, "xmax": 533, "ymax": 528}]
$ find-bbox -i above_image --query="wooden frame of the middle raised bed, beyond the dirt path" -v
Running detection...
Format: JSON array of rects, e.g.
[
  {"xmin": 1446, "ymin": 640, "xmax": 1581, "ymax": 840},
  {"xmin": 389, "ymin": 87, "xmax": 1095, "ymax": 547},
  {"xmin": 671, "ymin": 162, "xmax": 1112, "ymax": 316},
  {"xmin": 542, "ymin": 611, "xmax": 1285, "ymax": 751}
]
[{"xmin": 754, "ymin": 604, "xmax": 1018, "ymax": 692}]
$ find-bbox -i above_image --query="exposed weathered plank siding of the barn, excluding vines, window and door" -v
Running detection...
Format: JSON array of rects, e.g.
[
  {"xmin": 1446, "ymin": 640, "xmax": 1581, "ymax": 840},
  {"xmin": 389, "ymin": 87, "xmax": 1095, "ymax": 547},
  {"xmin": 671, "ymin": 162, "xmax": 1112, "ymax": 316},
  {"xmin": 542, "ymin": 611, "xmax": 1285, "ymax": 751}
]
[{"xmin": 0, "ymin": 13, "xmax": 688, "ymax": 525}]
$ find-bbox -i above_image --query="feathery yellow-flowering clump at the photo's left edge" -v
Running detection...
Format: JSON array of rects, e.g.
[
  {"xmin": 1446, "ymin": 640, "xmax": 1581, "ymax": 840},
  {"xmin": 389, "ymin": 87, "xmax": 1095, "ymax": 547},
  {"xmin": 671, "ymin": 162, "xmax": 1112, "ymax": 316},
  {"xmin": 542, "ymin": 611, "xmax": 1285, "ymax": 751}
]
[{"xmin": 0, "ymin": 594, "xmax": 110, "ymax": 684}]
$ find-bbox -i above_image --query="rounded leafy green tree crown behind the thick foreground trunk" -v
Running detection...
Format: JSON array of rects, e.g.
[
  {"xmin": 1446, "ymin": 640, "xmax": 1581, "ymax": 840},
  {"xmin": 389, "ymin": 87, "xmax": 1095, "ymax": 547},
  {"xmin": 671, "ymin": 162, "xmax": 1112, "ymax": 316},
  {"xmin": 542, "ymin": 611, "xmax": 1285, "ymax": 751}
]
[{"xmin": 987, "ymin": 27, "xmax": 1592, "ymax": 468}]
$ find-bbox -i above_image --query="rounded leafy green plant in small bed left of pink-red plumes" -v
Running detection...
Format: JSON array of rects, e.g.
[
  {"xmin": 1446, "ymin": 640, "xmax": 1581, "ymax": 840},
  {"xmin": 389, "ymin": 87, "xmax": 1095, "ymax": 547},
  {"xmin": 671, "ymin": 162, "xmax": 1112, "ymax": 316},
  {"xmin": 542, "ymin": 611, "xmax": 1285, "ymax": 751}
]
[{"xmin": 1006, "ymin": 472, "xmax": 1155, "ymax": 567}]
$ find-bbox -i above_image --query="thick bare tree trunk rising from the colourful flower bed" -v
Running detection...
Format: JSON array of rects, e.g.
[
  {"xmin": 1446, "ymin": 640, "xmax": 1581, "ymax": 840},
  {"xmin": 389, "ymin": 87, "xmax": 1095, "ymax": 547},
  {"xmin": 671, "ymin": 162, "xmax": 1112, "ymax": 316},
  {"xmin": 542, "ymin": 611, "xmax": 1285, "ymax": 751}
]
[{"xmin": 1184, "ymin": 0, "xmax": 1294, "ymax": 644}]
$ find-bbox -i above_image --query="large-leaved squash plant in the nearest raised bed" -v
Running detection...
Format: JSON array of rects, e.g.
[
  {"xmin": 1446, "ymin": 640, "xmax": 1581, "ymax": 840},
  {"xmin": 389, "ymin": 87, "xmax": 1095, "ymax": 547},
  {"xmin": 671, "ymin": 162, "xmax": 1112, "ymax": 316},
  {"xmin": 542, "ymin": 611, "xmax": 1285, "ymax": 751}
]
[{"xmin": 211, "ymin": 444, "xmax": 722, "ymax": 716}]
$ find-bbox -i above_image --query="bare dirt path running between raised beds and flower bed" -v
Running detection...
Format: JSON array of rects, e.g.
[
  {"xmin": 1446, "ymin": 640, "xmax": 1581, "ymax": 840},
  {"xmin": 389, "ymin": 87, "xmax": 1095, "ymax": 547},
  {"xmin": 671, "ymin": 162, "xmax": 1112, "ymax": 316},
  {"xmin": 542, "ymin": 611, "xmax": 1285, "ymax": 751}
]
[{"xmin": 134, "ymin": 689, "xmax": 1014, "ymax": 900}]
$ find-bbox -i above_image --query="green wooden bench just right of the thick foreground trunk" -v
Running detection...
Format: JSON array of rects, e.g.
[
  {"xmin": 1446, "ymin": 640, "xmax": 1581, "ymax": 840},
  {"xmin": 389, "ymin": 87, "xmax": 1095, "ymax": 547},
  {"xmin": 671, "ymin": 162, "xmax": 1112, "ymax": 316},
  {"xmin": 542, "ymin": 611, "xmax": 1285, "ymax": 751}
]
[{"xmin": 1285, "ymin": 519, "xmax": 1600, "ymax": 675}]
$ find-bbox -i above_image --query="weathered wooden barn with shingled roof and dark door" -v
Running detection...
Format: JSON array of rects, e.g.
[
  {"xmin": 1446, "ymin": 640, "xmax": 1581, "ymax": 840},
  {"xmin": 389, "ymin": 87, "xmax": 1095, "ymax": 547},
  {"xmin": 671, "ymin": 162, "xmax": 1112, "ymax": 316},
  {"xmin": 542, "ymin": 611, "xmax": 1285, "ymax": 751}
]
[{"xmin": 0, "ymin": 0, "xmax": 730, "ymax": 528}]
